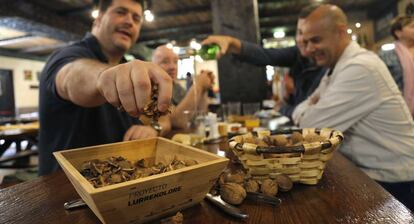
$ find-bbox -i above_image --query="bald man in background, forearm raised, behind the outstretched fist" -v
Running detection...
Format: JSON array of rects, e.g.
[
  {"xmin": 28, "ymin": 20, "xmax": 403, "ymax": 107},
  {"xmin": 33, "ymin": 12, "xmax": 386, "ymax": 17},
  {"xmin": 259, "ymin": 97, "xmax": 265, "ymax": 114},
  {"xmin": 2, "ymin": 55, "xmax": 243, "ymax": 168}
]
[{"xmin": 152, "ymin": 45, "xmax": 214, "ymax": 129}]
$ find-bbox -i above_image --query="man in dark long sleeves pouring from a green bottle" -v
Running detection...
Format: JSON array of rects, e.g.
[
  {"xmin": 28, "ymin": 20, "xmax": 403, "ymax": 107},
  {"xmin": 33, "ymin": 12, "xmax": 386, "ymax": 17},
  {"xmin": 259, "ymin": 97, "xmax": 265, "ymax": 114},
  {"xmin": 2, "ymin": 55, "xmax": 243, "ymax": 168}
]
[{"xmin": 202, "ymin": 5, "xmax": 325, "ymax": 117}]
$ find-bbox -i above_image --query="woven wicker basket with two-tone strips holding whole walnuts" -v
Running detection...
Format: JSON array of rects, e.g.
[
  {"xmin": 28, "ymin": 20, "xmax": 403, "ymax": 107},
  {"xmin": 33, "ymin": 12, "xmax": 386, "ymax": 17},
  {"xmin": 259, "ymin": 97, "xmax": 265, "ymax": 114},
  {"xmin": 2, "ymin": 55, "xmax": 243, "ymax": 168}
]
[{"xmin": 229, "ymin": 128, "xmax": 343, "ymax": 185}]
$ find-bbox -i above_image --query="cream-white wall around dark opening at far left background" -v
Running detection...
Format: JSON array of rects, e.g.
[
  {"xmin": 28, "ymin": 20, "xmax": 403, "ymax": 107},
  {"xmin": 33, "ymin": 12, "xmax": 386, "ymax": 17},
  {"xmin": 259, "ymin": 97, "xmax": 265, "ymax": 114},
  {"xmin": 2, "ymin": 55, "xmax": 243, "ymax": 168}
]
[{"xmin": 0, "ymin": 56, "xmax": 45, "ymax": 108}]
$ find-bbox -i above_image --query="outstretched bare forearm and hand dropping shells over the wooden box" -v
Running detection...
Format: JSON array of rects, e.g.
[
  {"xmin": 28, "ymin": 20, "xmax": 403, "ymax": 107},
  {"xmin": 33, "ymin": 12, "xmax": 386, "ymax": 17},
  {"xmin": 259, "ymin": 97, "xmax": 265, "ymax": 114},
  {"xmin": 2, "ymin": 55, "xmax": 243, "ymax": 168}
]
[{"xmin": 55, "ymin": 59, "xmax": 172, "ymax": 117}]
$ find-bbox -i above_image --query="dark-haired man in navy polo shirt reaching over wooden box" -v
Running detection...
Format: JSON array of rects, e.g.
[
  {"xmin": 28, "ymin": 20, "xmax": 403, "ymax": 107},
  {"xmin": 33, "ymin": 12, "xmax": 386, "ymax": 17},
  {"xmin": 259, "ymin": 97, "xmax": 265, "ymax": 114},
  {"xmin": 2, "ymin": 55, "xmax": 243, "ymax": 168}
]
[{"xmin": 39, "ymin": 0, "xmax": 172, "ymax": 175}]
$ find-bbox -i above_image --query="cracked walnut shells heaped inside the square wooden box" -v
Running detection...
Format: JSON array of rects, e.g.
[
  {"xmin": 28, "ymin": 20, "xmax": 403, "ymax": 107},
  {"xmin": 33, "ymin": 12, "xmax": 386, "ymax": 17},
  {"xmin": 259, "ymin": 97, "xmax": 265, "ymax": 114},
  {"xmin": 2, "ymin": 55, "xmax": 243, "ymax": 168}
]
[{"xmin": 80, "ymin": 156, "xmax": 198, "ymax": 188}]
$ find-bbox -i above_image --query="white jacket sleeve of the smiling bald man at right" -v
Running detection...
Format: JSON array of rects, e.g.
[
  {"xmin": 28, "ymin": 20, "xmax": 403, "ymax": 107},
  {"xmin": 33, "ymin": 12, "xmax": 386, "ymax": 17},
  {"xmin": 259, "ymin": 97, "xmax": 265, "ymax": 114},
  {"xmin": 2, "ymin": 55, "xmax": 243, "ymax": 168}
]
[{"xmin": 296, "ymin": 65, "xmax": 380, "ymax": 131}]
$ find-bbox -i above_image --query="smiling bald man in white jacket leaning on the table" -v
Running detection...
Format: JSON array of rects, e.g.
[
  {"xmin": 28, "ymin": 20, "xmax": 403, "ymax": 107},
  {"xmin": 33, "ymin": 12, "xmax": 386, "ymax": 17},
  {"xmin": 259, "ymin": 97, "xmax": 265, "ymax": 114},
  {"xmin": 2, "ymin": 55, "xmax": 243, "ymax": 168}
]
[{"xmin": 293, "ymin": 5, "xmax": 414, "ymax": 209}]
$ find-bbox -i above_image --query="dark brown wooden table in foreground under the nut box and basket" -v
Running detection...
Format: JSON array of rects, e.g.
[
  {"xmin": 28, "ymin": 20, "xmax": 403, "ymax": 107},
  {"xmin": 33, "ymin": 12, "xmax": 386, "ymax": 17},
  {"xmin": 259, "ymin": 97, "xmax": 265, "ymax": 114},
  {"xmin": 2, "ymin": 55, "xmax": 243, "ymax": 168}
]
[{"xmin": 0, "ymin": 138, "xmax": 414, "ymax": 224}]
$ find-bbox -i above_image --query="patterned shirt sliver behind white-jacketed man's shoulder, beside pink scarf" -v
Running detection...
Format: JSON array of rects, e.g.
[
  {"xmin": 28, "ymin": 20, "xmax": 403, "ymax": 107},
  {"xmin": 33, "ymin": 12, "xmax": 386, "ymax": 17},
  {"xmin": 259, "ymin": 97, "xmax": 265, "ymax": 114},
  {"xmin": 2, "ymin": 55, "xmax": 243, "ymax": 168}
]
[{"xmin": 379, "ymin": 50, "xmax": 404, "ymax": 92}]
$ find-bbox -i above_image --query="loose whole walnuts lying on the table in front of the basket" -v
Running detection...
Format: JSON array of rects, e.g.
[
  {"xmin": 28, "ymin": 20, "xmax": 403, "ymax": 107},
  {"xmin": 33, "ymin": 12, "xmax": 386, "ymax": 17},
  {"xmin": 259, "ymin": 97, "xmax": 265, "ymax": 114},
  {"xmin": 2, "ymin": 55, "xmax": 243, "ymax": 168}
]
[{"xmin": 211, "ymin": 170, "xmax": 293, "ymax": 205}]
